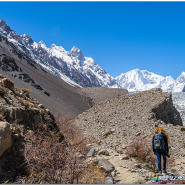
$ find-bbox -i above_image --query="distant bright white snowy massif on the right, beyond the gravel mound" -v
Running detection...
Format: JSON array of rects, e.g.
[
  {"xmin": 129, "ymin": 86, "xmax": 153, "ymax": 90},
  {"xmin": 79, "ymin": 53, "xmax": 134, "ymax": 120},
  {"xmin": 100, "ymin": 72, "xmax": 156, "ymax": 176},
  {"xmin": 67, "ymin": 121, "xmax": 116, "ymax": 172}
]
[{"xmin": 116, "ymin": 69, "xmax": 185, "ymax": 92}]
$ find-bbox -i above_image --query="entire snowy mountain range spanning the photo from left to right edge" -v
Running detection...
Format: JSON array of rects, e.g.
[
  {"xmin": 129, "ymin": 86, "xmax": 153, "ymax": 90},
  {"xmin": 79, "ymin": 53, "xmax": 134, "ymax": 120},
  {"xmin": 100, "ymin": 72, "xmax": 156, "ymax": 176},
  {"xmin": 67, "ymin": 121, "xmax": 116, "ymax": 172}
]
[{"xmin": 0, "ymin": 19, "xmax": 185, "ymax": 92}]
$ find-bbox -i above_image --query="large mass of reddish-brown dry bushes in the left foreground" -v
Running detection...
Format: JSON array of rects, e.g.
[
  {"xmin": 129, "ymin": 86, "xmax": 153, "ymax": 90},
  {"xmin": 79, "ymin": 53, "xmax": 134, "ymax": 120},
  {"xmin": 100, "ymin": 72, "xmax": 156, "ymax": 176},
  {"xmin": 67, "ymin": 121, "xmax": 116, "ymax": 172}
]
[{"xmin": 19, "ymin": 115, "xmax": 105, "ymax": 184}]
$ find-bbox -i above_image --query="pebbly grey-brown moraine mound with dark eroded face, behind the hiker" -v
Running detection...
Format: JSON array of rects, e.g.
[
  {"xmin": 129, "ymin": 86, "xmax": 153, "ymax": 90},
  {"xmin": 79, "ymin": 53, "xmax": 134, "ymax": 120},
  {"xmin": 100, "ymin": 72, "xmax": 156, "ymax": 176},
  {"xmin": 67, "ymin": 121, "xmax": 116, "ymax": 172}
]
[{"xmin": 74, "ymin": 89, "xmax": 185, "ymax": 157}]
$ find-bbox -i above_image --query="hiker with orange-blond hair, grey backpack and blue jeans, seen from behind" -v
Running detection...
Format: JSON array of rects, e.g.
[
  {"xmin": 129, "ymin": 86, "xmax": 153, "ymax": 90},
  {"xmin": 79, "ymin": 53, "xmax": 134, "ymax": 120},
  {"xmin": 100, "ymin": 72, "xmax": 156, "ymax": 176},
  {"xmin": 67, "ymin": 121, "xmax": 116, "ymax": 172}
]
[{"xmin": 152, "ymin": 127, "xmax": 169, "ymax": 174}]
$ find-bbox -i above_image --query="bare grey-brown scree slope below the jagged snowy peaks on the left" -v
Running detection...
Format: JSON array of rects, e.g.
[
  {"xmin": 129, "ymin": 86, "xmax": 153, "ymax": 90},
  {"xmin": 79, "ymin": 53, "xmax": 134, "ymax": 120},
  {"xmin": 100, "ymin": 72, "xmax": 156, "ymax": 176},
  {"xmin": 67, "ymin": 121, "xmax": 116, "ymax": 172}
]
[{"xmin": 0, "ymin": 36, "xmax": 91, "ymax": 117}]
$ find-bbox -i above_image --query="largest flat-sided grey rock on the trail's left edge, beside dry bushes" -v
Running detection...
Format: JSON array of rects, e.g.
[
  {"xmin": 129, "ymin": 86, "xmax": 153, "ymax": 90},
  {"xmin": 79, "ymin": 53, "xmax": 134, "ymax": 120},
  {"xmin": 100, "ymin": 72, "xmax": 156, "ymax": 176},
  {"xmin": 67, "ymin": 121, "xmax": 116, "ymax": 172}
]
[{"xmin": 98, "ymin": 158, "xmax": 115, "ymax": 174}]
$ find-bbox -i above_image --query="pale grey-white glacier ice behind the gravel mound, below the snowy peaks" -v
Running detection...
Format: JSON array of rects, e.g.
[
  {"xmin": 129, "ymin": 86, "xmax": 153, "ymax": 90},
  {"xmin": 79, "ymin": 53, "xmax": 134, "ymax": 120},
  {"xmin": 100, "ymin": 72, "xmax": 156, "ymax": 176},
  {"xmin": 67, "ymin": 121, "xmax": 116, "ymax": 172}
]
[{"xmin": 129, "ymin": 91, "xmax": 185, "ymax": 126}]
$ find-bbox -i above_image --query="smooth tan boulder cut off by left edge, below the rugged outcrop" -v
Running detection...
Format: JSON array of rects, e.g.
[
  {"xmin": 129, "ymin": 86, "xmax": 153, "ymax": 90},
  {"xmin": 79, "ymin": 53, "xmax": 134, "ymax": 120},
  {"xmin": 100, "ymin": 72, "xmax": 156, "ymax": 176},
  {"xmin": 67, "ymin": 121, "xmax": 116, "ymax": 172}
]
[{"xmin": 0, "ymin": 122, "xmax": 12, "ymax": 157}]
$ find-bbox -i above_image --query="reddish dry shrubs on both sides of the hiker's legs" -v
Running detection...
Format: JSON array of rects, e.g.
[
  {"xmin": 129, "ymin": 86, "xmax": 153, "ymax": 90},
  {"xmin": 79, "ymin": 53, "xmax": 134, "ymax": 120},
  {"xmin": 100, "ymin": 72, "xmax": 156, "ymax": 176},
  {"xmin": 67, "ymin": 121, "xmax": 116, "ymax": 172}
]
[{"xmin": 124, "ymin": 136, "xmax": 175, "ymax": 169}]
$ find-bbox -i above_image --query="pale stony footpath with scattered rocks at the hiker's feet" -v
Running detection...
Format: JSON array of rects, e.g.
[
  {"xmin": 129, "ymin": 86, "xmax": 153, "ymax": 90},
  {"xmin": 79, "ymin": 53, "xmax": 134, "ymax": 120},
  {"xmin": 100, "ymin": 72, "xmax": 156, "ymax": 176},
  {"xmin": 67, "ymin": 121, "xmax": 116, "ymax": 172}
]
[{"xmin": 85, "ymin": 148, "xmax": 185, "ymax": 184}]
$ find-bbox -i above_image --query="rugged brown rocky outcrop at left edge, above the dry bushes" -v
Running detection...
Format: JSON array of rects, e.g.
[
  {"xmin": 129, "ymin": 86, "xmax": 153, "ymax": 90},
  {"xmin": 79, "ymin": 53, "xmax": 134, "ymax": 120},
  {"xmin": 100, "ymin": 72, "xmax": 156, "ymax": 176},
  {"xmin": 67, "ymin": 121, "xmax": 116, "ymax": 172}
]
[{"xmin": 0, "ymin": 75, "xmax": 64, "ymax": 156}]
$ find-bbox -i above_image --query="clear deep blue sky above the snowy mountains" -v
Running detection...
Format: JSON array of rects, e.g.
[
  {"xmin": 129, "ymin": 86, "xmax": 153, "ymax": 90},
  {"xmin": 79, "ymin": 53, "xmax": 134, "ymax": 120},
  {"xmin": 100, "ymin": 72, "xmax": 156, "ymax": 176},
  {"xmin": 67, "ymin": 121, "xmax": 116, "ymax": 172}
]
[{"xmin": 0, "ymin": 2, "xmax": 185, "ymax": 79}]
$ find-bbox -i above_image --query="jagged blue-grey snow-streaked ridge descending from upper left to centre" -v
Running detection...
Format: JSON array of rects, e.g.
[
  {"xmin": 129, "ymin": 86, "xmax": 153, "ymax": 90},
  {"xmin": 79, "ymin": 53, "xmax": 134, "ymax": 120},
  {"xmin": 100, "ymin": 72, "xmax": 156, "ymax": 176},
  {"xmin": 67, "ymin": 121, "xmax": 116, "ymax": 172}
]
[{"xmin": 0, "ymin": 19, "xmax": 120, "ymax": 88}]
